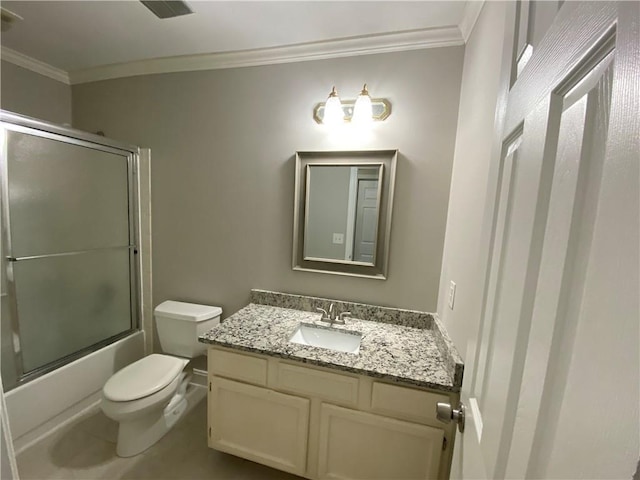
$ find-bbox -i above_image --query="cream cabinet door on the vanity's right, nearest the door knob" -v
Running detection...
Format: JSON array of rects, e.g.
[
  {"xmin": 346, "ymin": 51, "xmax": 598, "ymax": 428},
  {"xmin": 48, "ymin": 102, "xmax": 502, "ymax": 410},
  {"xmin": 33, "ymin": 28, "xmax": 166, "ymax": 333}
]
[{"xmin": 318, "ymin": 404, "xmax": 444, "ymax": 480}]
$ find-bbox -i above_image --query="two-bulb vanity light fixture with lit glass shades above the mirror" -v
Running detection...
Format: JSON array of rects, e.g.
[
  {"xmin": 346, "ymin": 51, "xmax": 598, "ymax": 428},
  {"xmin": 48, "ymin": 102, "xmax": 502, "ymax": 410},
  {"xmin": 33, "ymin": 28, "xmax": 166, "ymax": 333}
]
[{"xmin": 313, "ymin": 83, "xmax": 391, "ymax": 126}]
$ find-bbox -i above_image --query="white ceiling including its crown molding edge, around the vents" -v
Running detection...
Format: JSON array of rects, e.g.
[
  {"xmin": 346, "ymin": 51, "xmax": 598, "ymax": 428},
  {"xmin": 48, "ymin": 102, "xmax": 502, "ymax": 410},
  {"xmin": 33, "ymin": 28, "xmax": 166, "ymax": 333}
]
[{"xmin": 1, "ymin": 0, "xmax": 475, "ymax": 83}]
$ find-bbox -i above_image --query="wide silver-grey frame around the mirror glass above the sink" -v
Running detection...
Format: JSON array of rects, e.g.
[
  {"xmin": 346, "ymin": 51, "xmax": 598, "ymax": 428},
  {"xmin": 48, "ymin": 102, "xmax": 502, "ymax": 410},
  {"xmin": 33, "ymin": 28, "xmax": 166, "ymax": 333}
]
[{"xmin": 292, "ymin": 150, "xmax": 398, "ymax": 280}]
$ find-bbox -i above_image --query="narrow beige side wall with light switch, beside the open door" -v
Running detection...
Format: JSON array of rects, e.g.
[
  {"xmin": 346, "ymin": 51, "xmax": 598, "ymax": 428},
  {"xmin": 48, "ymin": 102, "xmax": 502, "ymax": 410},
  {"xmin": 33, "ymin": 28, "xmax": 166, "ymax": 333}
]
[{"xmin": 438, "ymin": 2, "xmax": 505, "ymax": 362}]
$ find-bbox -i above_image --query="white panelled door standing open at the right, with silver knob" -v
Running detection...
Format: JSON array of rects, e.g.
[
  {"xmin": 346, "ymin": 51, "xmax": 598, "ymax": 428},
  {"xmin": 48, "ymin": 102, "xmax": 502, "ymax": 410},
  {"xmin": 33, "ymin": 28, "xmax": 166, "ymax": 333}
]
[{"xmin": 458, "ymin": 2, "xmax": 640, "ymax": 478}]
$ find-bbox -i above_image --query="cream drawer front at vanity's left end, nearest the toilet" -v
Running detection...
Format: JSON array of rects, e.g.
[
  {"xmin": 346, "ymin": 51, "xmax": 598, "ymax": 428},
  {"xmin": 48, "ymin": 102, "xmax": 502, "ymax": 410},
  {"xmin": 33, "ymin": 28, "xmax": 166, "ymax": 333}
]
[{"xmin": 208, "ymin": 348, "xmax": 267, "ymax": 386}]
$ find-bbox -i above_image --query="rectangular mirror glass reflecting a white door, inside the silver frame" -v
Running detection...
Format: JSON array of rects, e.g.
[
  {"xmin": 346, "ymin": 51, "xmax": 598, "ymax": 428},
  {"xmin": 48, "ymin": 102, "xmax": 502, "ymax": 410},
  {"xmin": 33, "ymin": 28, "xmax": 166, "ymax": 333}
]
[{"xmin": 304, "ymin": 163, "xmax": 384, "ymax": 266}]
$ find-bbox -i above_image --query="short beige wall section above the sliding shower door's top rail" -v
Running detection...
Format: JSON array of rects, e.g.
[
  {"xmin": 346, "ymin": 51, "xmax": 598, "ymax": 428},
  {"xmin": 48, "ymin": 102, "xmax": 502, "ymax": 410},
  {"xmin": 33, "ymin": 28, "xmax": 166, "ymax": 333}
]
[{"xmin": 0, "ymin": 61, "xmax": 71, "ymax": 125}]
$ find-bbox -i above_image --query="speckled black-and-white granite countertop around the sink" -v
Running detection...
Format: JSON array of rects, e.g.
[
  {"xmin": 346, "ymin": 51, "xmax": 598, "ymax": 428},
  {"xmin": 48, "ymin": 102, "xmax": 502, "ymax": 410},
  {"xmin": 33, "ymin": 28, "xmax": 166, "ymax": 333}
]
[{"xmin": 200, "ymin": 292, "xmax": 464, "ymax": 392}]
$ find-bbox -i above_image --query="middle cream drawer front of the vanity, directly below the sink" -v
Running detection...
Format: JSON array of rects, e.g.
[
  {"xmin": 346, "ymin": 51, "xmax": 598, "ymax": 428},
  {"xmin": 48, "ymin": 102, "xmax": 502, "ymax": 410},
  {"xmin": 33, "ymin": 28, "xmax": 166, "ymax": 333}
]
[{"xmin": 276, "ymin": 363, "xmax": 358, "ymax": 406}]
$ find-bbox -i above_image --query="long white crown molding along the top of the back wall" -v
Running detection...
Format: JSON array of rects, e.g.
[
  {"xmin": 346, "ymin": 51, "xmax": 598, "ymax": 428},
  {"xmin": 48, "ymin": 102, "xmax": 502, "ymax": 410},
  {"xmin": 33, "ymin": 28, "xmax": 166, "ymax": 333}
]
[{"xmin": 69, "ymin": 26, "xmax": 464, "ymax": 84}]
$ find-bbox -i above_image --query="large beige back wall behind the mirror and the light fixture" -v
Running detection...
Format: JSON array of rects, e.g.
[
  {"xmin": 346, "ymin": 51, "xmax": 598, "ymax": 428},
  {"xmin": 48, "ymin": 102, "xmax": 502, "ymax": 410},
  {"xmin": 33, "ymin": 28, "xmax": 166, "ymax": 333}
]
[{"xmin": 73, "ymin": 47, "xmax": 464, "ymax": 316}]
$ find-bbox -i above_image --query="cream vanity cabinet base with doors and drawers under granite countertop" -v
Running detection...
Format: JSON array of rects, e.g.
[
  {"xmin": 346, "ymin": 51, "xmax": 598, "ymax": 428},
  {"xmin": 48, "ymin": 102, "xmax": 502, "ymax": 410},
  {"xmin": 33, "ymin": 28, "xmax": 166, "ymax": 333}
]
[{"xmin": 209, "ymin": 346, "xmax": 458, "ymax": 480}]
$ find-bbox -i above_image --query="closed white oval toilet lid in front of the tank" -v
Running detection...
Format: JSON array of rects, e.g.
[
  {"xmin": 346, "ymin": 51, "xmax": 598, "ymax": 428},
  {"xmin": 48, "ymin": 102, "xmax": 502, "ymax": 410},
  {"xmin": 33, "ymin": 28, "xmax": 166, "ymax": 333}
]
[{"xmin": 102, "ymin": 353, "xmax": 189, "ymax": 402}]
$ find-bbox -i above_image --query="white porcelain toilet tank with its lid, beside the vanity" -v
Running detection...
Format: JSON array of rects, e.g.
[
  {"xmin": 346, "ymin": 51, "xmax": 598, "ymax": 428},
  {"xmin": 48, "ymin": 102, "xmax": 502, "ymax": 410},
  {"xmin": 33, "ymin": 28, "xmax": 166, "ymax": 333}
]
[{"xmin": 153, "ymin": 300, "xmax": 222, "ymax": 358}]
